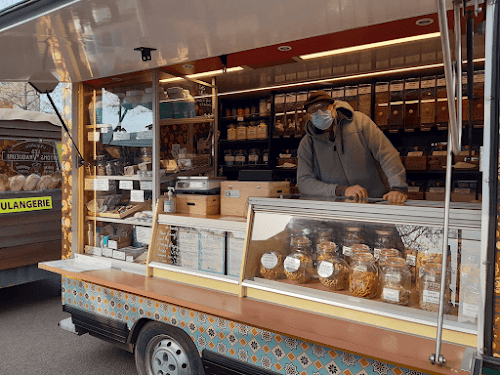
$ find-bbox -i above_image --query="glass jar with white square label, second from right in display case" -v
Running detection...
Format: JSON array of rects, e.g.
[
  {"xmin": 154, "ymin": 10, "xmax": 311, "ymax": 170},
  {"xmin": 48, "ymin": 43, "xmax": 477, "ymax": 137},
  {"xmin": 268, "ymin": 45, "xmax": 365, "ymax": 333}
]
[{"xmin": 380, "ymin": 258, "xmax": 411, "ymax": 305}]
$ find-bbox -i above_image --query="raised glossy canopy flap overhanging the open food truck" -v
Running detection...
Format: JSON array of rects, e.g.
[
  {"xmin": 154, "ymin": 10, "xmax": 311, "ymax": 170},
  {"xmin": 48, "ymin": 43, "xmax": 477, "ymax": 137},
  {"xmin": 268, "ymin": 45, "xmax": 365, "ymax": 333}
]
[{"xmin": 0, "ymin": 0, "xmax": 452, "ymax": 82}]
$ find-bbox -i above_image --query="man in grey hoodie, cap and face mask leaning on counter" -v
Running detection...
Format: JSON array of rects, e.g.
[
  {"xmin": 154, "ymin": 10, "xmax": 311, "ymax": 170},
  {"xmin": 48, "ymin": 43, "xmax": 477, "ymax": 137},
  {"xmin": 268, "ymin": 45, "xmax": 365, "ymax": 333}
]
[{"xmin": 297, "ymin": 91, "xmax": 408, "ymax": 203}]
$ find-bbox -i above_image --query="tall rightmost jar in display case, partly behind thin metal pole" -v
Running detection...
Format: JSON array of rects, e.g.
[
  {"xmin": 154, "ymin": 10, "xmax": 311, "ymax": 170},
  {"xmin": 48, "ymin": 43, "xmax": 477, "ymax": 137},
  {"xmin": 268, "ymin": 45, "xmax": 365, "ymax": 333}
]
[{"xmin": 419, "ymin": 263, "xmax": 450, "ymax": 314}]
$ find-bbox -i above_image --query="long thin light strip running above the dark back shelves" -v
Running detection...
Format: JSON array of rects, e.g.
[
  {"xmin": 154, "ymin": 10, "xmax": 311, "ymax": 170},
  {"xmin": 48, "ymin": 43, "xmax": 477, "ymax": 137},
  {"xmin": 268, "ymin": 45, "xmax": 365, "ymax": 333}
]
[{"xmin": 217, "ymin": 58, "xmax": 485, "ymax": 96}]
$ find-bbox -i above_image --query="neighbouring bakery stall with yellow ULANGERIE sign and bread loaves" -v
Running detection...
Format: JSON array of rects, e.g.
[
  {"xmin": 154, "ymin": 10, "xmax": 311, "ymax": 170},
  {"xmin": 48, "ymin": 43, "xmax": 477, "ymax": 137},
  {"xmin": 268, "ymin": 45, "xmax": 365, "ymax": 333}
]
[{"xmin": 0, "ymin": 108, "xmax": 62, "ymax": 288}]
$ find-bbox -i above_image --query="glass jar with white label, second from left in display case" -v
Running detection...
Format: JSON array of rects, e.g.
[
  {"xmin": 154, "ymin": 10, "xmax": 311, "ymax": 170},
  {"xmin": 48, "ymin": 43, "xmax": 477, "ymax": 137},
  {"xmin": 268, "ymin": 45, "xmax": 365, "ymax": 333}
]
[{"xmin": 284, "ymin": 237, "xmax": 313, "ymax": 284}]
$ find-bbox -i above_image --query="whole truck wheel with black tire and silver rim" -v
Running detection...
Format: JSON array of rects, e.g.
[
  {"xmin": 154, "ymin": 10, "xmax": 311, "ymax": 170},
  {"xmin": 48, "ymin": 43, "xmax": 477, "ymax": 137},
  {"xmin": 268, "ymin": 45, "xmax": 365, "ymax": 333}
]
[{"xmin": 134, "ymin": 322, "xmax": 205, "ymax": 375}]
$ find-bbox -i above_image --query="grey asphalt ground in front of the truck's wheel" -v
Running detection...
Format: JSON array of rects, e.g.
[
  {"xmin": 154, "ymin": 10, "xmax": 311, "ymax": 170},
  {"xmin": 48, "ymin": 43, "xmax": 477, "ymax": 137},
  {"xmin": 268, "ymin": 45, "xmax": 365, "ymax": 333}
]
[{"xmin": 0, "ymin": 278, "xmax": 137, "ymax": 375}]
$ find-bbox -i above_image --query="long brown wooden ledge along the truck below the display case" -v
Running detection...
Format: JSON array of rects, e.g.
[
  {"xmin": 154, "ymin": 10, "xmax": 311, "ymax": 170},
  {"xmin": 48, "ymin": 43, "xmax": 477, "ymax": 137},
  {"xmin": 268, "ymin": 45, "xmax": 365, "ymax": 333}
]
[{"xmin": 39, "ymin": 264, "xmax": 468, "ymax": 375}]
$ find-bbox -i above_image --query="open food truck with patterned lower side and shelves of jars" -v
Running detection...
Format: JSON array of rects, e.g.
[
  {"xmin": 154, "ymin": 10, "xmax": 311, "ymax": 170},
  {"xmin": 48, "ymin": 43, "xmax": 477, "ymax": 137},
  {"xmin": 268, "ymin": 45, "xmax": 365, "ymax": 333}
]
[{"xmin": 0, "ymin": 0, "xmax": 500, "ymax": 375}]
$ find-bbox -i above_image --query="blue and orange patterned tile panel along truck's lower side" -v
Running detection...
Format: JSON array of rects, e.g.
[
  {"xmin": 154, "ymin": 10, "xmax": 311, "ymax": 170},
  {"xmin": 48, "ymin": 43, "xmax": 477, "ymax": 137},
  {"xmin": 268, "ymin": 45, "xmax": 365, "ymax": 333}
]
[{"xmin": 62, "ymin": 277, "xmax": 430, "ymax": 375}]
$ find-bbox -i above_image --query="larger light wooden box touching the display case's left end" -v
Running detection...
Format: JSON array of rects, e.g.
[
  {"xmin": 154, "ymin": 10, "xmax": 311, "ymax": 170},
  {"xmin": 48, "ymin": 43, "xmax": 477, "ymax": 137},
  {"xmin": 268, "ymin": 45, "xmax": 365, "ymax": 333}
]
[{"xmin": 220, "ymin": 181, "xmax": 290, "ymax": 217}]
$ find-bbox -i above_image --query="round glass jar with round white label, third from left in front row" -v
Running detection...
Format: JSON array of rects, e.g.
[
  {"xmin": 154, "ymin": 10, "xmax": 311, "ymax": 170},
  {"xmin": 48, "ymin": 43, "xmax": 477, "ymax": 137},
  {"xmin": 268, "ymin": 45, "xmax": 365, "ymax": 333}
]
[{"xmin": 317, "ymin": 253, "xmax": 350, "ymax": 290}]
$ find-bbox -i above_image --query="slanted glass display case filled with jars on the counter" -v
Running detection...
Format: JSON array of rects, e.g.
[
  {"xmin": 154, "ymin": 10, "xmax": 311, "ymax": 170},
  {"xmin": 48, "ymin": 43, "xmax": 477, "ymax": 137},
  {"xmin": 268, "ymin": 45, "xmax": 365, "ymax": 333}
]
[{"xmin": 242, "ymin": 197, "xmax": 481, "ymax": 345}]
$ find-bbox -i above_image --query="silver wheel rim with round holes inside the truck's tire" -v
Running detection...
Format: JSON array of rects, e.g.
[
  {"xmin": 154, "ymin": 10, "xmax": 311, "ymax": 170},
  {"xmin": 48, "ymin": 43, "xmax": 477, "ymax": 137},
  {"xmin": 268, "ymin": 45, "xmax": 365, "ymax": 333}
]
[{"xmin": 146, "ymin": 335, "xmax": 189, "ymax": 375}]
